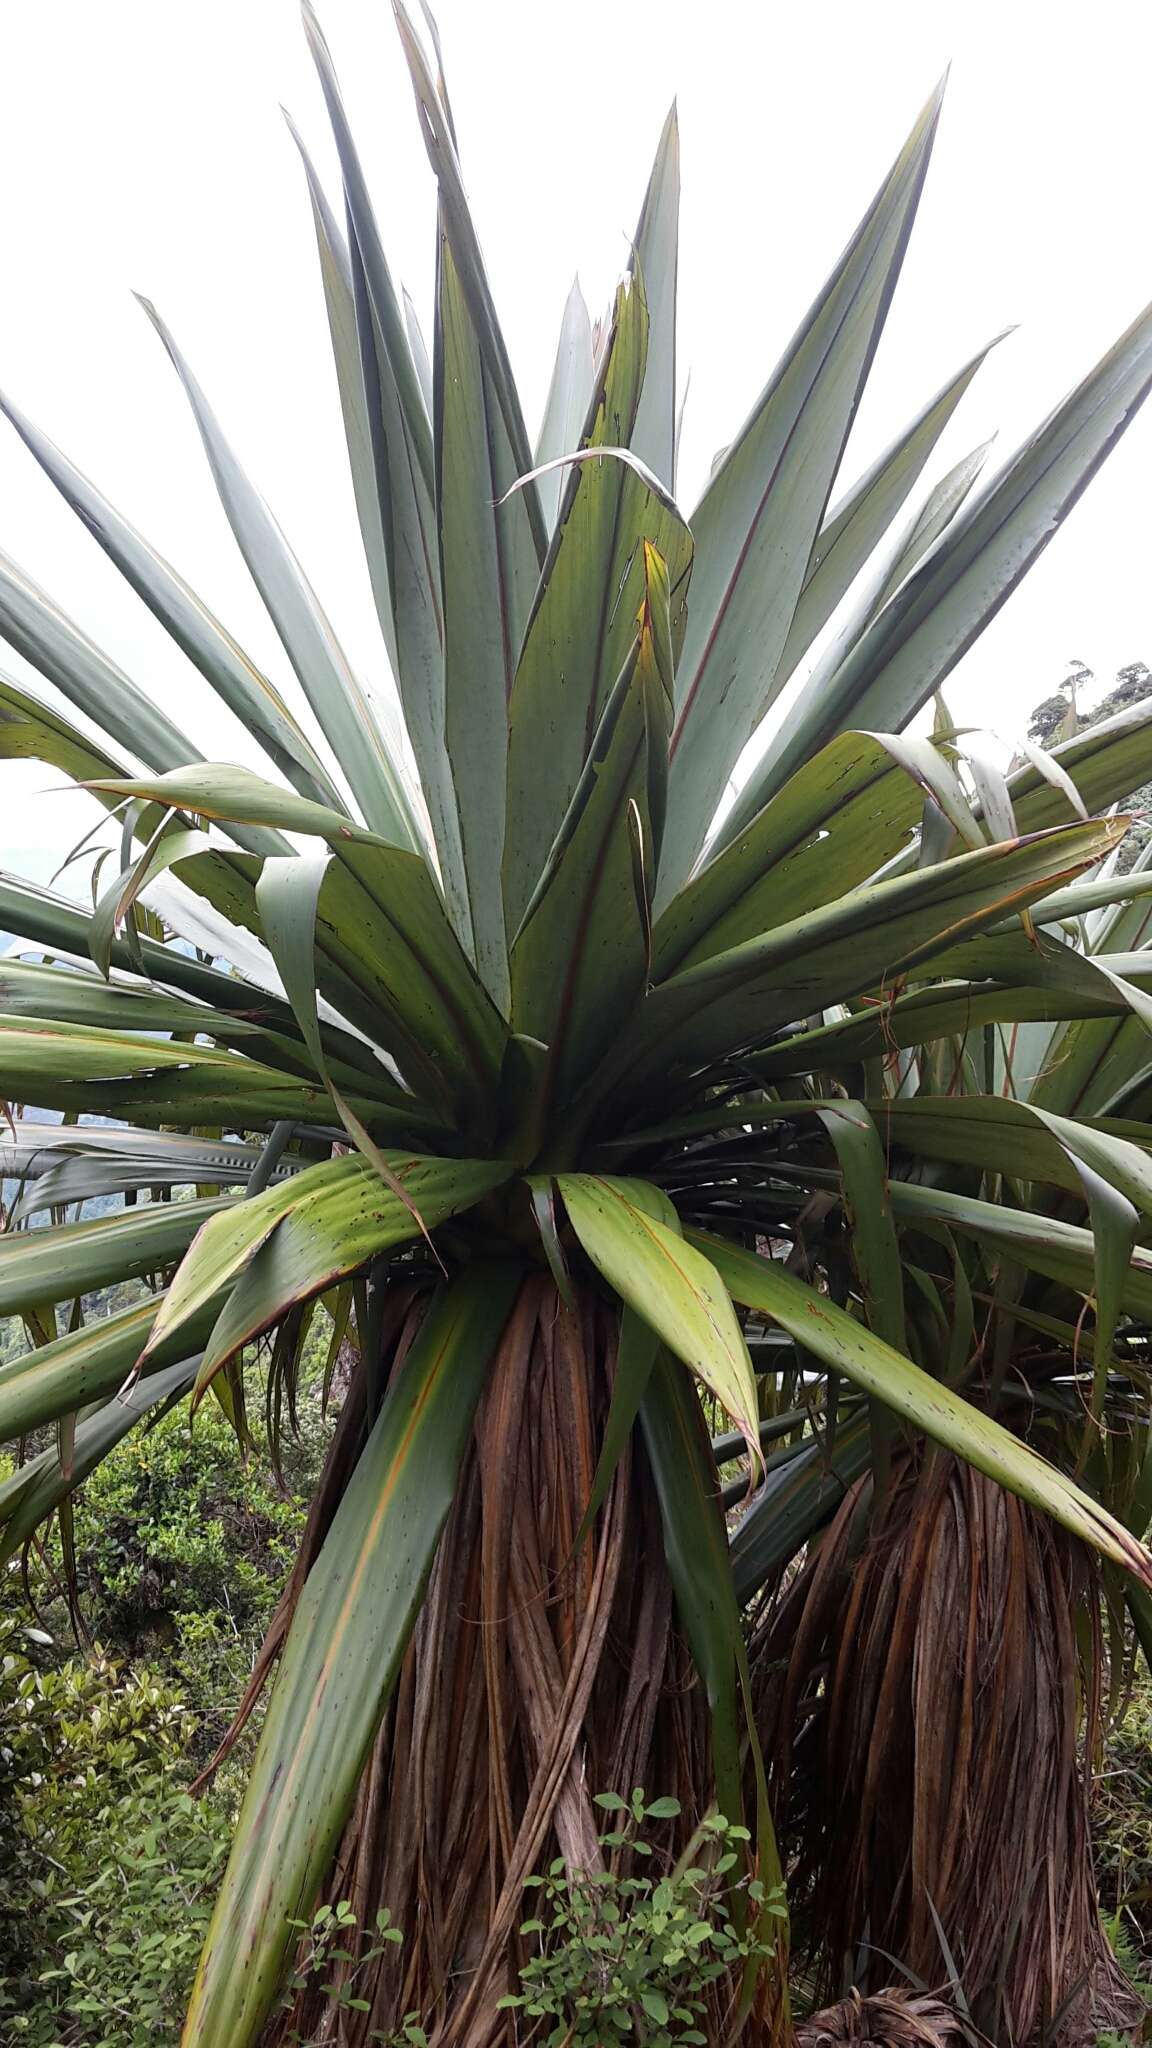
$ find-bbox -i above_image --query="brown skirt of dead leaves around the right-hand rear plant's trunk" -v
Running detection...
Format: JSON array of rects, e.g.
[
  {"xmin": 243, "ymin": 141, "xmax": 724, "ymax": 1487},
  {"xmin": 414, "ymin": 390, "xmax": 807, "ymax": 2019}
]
[{"xmin": 754, "ymin": 1454, "xmax": 1136, "ymax": 2044}]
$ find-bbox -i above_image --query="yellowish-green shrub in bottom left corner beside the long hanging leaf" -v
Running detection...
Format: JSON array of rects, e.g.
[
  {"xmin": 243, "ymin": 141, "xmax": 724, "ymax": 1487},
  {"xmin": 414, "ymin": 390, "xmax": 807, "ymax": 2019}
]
[{"xmin": 0, "ymin": 1616, "xmax": 232, "ymax": 2048}]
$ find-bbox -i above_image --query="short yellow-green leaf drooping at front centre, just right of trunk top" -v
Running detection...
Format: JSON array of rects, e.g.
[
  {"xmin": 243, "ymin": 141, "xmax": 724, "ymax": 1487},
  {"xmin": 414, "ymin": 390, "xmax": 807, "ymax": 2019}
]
[{"xmin": 556, "ymin": 1174, "xmax": 760, "ymax": 1468}]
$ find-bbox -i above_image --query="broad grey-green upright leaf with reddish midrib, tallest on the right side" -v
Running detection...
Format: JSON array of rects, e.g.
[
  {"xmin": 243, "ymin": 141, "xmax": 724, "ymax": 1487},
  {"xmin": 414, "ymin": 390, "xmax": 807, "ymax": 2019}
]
[{"xmin": 662, "ymin": 92, "xmax": 941, "ymax": 903}]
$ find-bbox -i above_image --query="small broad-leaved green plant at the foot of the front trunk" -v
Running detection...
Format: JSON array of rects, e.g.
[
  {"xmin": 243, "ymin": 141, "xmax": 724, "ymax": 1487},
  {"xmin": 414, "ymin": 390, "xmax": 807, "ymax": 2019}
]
[{"xmin": 500, "ymin": 1788, "xmax": 785, "ymax": 2048}]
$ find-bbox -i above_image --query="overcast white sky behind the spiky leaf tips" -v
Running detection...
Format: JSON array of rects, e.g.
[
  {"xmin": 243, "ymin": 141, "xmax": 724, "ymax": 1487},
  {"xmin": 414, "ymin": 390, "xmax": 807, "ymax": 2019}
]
[{"xmin": 0, "ymin": 0, "xmax": 1152, "ymax": 879}]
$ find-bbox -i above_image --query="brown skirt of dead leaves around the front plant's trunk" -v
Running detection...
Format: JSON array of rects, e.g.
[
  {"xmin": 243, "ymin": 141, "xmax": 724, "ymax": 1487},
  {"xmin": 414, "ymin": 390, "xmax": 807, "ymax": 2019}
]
[{"xmin": 266, "ymin": 1278, "xmax": 725, "ymax": 2048}]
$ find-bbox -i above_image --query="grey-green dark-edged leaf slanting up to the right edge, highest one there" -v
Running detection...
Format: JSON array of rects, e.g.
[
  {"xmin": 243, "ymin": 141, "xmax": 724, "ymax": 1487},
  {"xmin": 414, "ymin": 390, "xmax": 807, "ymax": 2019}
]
[{"xmin": 760, "ymin": 309, "xmax": 1152, "ymax": 795}]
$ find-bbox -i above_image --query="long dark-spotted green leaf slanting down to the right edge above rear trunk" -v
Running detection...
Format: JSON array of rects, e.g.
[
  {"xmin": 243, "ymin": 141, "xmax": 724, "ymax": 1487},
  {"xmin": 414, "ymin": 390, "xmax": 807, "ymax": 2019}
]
[{"xmin": 689, "ymin": 1231, "xmax": 1152, "ymax": 1587}]
